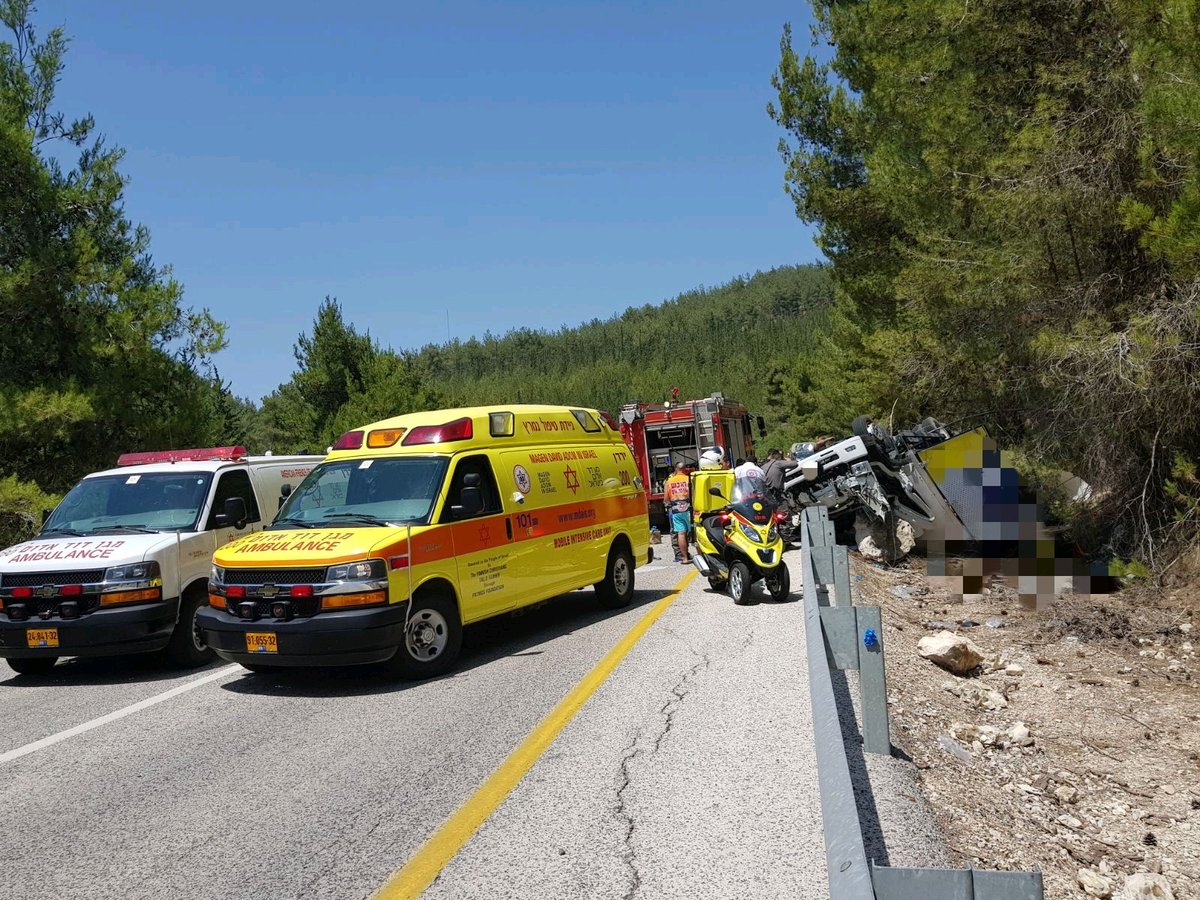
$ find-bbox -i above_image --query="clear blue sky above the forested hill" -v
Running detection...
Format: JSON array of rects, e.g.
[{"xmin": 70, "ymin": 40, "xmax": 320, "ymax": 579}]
[{"xmin": 42, "ymin": 0, "xmax": 818, "ymax": 400}]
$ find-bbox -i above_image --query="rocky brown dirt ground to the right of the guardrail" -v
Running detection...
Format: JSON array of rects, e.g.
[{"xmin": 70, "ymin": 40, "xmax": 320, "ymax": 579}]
[{"xmin": 851, "ymin": 553, "xmax": 1200, "ymax": 900}]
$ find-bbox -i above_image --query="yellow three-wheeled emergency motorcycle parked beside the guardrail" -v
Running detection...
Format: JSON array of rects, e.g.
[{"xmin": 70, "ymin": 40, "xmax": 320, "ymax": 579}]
[{"xmin": 691, "ymin": 470, "xmax": 792, "ymax": 606}]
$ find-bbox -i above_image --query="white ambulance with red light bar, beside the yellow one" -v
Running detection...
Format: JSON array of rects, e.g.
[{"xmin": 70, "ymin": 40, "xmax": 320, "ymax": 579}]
[{"xmin": 0, "ymin": 446, "xmax": 323, "ymax": 674}]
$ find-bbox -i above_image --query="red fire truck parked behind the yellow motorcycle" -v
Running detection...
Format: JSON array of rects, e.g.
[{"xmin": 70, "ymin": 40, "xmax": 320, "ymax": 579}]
[{"xmin": 618, "ymin": 394, "xmax": 764, "ymax": 530}]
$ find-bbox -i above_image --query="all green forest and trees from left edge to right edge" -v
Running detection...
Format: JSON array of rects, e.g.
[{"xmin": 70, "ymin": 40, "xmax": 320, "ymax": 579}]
[{"xmin": 0, "ymin": 0, "xmax": 1200, "ymax": 569}]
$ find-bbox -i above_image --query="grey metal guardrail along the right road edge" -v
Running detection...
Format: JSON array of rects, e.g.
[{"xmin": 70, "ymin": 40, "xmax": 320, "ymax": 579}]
[{"xmin": 800, "ymin": 506, "xmax": 1043, "ymax": 900}]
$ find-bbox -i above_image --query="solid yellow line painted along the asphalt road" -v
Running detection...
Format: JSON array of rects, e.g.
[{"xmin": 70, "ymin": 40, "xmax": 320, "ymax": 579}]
[{"xmin": 376, "ymin": 569, "xmax": 696, "ymax": 900}]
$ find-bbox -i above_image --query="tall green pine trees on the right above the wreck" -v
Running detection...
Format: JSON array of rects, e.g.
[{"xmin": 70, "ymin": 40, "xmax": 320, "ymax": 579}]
[{"xmin": 768, "ymin": 0, "xmax": 1200, "ymax": 564}]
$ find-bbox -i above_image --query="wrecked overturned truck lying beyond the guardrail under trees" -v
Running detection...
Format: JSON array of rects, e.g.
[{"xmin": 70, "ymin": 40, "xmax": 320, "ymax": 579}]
[{"xmin": 784, "ymin": 416, "xmax": 993, "ymax": 562}]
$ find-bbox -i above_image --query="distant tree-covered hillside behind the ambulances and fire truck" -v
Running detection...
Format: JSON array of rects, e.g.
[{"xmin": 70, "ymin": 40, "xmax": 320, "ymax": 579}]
[{"xmin": 250, "ymin": 266, "xmax": 832, "ymax": 458}]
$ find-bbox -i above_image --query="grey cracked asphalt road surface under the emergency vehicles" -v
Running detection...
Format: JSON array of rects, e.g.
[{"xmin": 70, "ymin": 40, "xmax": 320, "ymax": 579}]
[{"xmin": 0, "ymin": 563, "xmax": 824, "ymax": 900}]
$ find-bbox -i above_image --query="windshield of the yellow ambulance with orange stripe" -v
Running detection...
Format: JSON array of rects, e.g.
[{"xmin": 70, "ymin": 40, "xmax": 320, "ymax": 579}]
[{"xmin": 271, "ymin": 456, "xmax": 446, "ymax": 528}]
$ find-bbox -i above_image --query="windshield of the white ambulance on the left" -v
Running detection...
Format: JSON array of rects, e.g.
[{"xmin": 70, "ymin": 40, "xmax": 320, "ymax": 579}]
[{"xmin": 42, "ymin": 472, "xmax": 212, "ymax": 535}]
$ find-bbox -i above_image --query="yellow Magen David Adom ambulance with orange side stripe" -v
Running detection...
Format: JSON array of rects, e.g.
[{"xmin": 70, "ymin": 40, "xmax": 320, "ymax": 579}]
[{"xmin": 197, "ymin": 406, "xmax": 653, "ymax": 678}]
